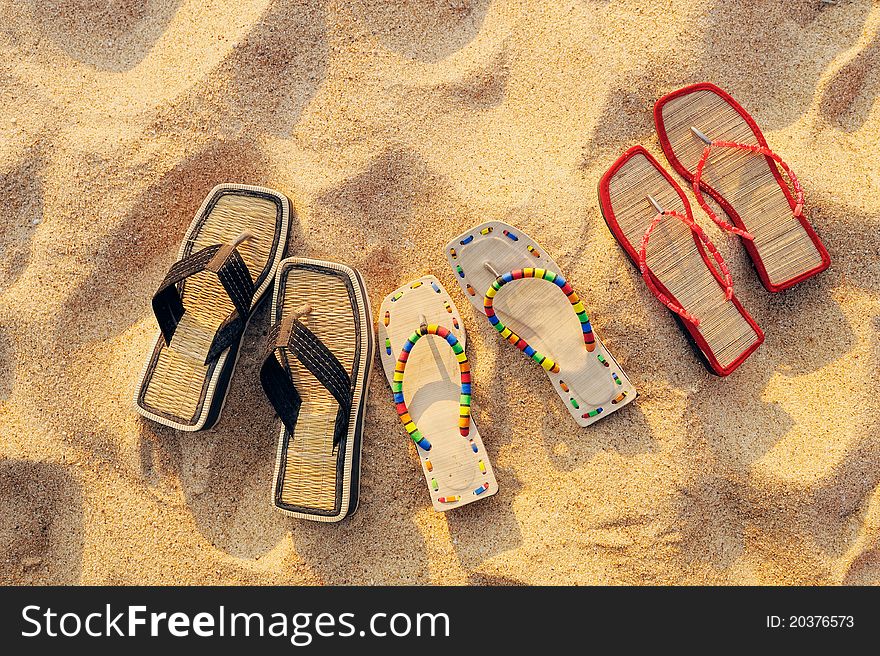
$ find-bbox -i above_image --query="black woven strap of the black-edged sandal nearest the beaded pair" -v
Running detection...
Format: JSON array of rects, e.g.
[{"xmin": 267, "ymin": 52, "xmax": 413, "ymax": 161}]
[{"xmin": 260, "ymin": 315, "xmax": 353, "ymax": 449}]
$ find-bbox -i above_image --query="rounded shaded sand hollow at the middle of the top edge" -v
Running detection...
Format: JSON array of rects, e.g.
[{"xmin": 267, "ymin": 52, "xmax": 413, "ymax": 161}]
[{"xmin": 348, "ymin": 0, "xmax": 491, "ymax": 62}]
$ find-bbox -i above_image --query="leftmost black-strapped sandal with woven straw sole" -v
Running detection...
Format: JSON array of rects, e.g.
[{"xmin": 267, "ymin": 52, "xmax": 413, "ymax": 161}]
[{"xmin": 135, "ymin": 184, "xmax": 290, "ymax": 431}]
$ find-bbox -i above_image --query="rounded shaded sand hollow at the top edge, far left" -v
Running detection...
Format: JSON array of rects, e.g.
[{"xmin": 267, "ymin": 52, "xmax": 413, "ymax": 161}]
[{"xmin": 28, "ymin": 0, "xmax": 181, "ymax": 72}]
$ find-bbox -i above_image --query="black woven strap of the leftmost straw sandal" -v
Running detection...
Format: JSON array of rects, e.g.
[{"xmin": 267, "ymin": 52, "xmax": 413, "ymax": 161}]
[{"xmin": 153, "ymin": 244, "xmax": 255, "ymax": 364}]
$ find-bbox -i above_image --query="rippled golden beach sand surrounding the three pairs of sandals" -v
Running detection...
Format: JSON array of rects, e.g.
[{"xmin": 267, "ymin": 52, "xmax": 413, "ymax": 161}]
[{"xmin": 0, "ymin": 0, "xmax": 880, "ymax": 585}]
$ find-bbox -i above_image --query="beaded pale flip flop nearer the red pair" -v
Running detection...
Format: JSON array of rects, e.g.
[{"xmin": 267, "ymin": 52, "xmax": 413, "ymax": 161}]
[{"xmin": 446, "ymin": 221, "xmax": 636, "ymax": 426}]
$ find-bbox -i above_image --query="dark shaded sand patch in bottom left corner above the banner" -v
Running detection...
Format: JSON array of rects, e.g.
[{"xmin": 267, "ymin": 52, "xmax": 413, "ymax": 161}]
[{"xmin": 0, "ymin": 460, "xmax": 83, "ymax": 585}]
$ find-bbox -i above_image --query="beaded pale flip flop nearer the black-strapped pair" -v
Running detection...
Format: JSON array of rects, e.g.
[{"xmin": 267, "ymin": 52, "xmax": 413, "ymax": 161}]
[{"xmin": 379, "ymin": 276, "xmax": 498, "ymax": 511}]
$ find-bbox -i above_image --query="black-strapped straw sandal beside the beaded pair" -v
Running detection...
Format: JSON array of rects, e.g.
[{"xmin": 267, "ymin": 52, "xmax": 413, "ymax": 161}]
[{"xmin": 260, "ymin": 257, "xmax": 373, "ymax": 522}]
